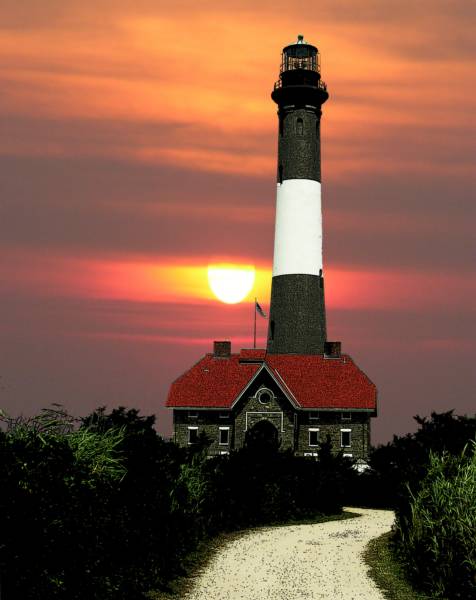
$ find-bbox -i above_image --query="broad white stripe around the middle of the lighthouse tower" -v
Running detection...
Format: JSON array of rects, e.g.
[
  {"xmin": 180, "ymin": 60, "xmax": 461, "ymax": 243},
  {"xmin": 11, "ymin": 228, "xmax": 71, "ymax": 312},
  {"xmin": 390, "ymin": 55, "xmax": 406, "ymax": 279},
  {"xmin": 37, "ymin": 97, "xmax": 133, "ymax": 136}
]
[{"xmin": 273, "ymin": 179, "xmax": 322, "ymax": 277}]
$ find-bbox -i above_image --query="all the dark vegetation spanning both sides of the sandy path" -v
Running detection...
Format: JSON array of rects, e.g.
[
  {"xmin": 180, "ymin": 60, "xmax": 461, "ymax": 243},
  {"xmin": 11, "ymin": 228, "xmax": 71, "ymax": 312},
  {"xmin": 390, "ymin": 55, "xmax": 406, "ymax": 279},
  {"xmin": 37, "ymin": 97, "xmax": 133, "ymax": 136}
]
[{"xmin": 0, "ymin": 407, "xmax": 476, "ymax": 600}]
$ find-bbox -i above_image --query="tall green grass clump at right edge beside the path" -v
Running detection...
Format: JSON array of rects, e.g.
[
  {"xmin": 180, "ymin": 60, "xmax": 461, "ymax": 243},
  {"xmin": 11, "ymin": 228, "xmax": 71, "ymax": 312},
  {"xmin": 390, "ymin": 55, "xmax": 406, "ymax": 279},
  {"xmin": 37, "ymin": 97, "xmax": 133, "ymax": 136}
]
[{"xmin": 397, "ymin": 442, "xmax": 476, "ymax": 598}]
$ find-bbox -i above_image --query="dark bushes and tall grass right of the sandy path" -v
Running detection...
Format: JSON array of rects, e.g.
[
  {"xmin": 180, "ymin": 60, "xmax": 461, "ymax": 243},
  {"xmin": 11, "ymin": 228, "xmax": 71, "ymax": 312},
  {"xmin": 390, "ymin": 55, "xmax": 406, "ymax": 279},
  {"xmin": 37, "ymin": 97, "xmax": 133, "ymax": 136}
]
[{"xmin": 346, "ymin": 411, "xmax": 476, "ymax": 600}]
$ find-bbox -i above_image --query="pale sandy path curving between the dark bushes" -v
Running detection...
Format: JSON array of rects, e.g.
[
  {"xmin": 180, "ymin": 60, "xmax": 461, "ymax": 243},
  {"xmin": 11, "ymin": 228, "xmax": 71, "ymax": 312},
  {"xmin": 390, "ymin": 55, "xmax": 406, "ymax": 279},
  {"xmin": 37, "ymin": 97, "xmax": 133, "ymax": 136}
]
[{"xmin": 184, "ymin": 508, "xmax": 394, "ymax": 600}]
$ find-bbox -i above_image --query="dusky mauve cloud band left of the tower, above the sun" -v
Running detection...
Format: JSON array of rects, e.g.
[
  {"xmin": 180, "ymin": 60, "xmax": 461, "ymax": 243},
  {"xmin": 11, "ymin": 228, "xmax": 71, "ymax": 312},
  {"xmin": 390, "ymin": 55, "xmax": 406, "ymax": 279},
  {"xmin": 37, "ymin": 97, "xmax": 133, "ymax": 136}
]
[{"xmin": 0, "ymin": 151, "xmax": 274, "ymax": 256}]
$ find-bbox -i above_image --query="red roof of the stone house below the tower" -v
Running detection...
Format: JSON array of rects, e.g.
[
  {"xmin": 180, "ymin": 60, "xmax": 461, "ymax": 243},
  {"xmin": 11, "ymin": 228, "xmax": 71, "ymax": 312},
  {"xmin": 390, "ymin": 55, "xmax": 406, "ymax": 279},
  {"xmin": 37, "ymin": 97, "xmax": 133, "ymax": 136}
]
[{"xmin": 166, "ymin": 350, "xmax": 377, "ymax": 410}]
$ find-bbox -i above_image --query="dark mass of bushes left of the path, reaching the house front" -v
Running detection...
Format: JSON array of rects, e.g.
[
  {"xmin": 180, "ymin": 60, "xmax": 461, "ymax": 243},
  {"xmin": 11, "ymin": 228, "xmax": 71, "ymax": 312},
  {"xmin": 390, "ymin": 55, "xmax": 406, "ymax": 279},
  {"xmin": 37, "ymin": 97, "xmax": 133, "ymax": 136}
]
[{"xmin": 0, "ymin": 407, "xmax": 351, "ymax": 600}]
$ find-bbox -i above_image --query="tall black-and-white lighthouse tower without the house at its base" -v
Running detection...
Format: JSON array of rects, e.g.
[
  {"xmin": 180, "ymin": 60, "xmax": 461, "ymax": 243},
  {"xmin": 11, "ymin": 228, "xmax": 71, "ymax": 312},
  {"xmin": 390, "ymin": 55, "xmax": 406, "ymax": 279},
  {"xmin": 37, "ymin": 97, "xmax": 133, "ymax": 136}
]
[{"xmin": 267, "ymin": 35, "xmax": 329, "ymax": 354}]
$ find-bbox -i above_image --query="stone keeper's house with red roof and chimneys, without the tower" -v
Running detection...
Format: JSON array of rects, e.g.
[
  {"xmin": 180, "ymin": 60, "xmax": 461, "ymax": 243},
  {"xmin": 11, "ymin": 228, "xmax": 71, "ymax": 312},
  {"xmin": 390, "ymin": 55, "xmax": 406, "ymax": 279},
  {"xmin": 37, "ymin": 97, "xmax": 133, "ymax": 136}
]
[{"xmin": 167, "ymin": 341, "xmax": 377, "ymax": 460}]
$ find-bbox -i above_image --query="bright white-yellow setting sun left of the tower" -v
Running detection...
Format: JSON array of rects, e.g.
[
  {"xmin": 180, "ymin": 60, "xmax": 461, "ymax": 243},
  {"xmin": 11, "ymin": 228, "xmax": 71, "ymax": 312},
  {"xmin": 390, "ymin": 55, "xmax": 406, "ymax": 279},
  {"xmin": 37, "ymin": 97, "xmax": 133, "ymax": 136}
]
[{"xmin": 208, "ymin": 264, "xmax": 255, "ymax": 304}]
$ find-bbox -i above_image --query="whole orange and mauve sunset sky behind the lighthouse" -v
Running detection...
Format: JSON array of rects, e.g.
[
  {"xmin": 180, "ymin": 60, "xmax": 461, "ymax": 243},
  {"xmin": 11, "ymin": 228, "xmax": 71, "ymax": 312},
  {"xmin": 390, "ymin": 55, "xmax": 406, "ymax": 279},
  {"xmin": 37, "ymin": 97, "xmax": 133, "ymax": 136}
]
[{"xmin": 0, "ymin": 0, "xmax": 476, "ymax": 440}]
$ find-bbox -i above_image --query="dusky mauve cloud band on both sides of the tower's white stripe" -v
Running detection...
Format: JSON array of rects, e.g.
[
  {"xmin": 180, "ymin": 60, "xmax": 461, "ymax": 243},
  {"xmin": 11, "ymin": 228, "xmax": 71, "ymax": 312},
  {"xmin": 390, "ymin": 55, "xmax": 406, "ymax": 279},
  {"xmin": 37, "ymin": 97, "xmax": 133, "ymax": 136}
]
[{"xmin": 0, "ymin": 148, "xmax": 475, "ymax": 270}]
